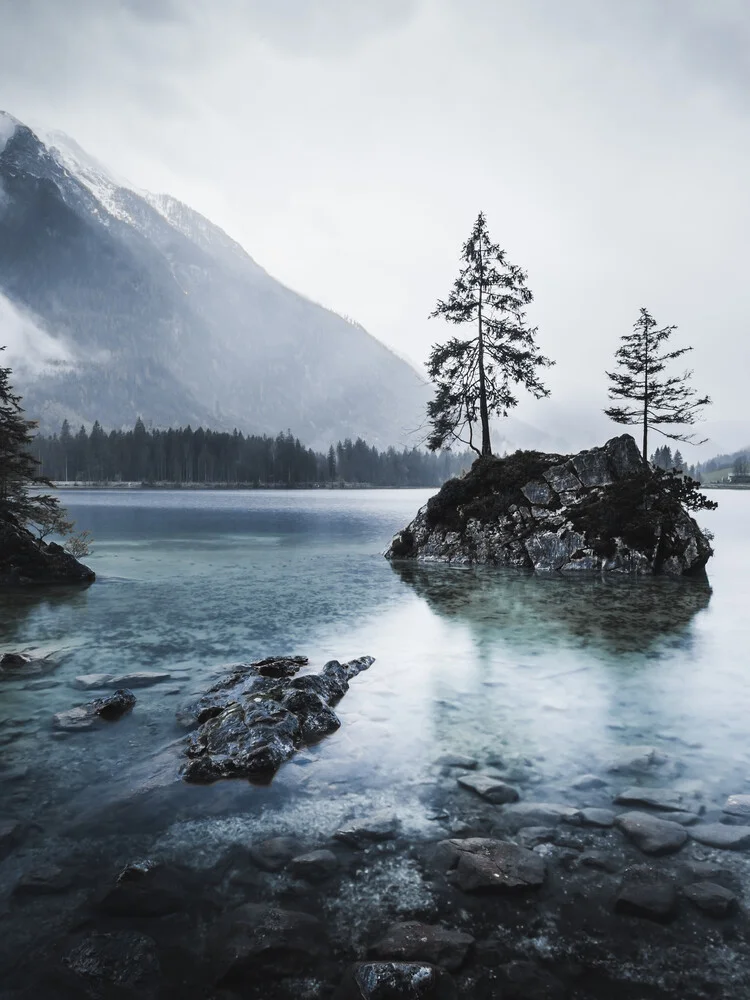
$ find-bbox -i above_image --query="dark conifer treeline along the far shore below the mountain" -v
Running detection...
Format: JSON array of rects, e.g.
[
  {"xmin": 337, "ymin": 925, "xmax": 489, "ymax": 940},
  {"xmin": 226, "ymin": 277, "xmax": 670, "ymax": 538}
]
[{"xmin": 33, "ymin": 418, "xmax": 472, "ymax": 487}]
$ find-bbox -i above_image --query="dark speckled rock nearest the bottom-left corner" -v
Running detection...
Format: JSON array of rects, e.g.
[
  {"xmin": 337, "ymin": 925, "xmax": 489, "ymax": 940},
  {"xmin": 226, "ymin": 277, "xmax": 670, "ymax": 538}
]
[{"xmin": 63, "ymin": 930, "xmax": 161, "ymax": 1000}]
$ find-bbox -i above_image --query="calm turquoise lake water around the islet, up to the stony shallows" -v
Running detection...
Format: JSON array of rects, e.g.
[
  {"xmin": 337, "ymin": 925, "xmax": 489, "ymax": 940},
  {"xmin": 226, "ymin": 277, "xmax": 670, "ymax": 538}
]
[{"xmin": 0, "ymin": 491, "xmax": 750, "ymax": 876}]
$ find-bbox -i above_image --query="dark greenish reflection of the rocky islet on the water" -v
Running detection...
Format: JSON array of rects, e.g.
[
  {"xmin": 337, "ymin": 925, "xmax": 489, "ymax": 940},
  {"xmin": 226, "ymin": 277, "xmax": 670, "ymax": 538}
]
[{"xmin": 392, "ymin": 561, "xmax": 711, "ymax": 653}]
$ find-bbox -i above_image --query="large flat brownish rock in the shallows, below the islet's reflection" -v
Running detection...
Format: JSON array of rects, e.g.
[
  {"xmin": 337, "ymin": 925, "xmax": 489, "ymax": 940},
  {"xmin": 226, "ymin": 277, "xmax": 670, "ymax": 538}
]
[{"xmin": 437, "ymin": 837, "xmax": 546, "ymax": 892}]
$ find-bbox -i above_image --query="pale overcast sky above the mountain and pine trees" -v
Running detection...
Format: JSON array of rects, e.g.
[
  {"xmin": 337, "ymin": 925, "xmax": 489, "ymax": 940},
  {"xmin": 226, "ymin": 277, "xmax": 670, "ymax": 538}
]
[{"xmin": 0, "ymin": 0, "xmax": 750, "ymax": 459}]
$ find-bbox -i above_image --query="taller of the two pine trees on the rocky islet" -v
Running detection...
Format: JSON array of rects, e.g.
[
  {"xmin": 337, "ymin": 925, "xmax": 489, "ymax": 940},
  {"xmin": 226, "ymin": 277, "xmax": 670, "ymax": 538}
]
[{"xmin": 427, "ymin": 212, "xmax": 554, "ymax": 455}]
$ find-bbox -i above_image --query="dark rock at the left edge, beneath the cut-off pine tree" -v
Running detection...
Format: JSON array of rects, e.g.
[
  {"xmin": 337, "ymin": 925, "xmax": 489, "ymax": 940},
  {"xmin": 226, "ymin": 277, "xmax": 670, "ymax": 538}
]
[{"xmin": 0, "ymin": 521, "xmax": 96, "ymax": 587}]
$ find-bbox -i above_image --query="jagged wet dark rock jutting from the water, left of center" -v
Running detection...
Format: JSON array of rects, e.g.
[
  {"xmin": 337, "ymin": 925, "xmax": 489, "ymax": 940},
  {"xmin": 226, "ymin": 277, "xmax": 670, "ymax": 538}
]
[{"xmin": 181, "ymin": 656, "xmax": 373, "ymax": 783}]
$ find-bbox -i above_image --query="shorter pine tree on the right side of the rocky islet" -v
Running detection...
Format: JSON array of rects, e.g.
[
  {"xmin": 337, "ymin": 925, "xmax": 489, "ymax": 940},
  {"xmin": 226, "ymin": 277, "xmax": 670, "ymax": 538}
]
[{"xmin": 604, "ymin": 309, "xmax": 711, "ymax": 462}]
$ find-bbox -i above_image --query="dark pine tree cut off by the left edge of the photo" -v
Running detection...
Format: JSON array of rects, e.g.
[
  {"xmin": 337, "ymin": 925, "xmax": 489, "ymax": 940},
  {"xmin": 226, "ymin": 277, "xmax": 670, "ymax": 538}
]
[{"xmin": 0, "ymin": 347, "xmax": 61, "ymax": 533}]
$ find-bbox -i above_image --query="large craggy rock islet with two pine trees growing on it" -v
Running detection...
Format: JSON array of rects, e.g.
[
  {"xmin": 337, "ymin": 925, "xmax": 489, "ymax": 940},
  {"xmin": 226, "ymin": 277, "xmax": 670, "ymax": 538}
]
[{"xmin": 385, "ymin": 434, "xmax": 712, "ymax": 576}]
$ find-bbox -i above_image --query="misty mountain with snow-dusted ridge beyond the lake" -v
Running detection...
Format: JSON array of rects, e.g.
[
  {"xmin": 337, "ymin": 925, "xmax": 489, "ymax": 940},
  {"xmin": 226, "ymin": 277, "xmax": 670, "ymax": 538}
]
[{"xmin": 0, "ymin": 112, "xmax": 428, "ymax": 448}]
